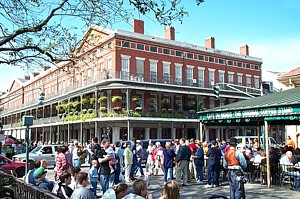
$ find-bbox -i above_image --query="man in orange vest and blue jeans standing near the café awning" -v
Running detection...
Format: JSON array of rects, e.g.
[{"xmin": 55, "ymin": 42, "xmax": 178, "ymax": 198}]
[{"xmin": 223, "ymin": 138, "xmax": 247, "ymax": 199}]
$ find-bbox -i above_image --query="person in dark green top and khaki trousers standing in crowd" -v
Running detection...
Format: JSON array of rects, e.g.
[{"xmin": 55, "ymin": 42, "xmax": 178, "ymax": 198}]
[{"xmin": 176, "ymin": 138, "xmax": 191, "ymax": 186}]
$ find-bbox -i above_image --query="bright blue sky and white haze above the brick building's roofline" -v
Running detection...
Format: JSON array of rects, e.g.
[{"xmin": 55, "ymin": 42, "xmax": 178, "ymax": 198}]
[{"xmin": 0, "ymin": 0, "xmax": 300, "ymax": 91}]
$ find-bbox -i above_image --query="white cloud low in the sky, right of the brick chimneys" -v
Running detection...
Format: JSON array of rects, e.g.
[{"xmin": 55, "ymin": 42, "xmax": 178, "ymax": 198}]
[{"xmin": 250, "ymin": 38, "xmax": 300, "ymax": 72}]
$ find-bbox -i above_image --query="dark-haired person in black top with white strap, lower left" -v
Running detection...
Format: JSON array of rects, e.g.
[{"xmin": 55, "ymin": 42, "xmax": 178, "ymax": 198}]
[{"xmin": 57, "ymin": 173, "xmax": 73, "ymax": 199}]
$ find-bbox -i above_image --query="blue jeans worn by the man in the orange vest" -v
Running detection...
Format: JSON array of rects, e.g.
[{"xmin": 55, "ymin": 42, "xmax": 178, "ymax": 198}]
[{"xmin": 228, "ymin": 170, "xmax": 244, "ymax": 199}]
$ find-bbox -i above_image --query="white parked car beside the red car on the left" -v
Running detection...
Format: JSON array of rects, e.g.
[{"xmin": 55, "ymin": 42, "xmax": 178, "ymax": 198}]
[{"xmin": 13, "ymin": 145, "xmax": 62, "ymax": 167}]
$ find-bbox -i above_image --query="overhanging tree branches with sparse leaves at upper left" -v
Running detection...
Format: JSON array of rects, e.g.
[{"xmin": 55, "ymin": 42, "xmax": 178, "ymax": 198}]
[{"xmin": 0, "ymin": 0, "xmax": 203, "ymax": 69}]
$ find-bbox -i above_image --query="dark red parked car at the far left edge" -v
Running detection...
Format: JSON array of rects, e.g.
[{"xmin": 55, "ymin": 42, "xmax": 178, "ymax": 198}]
[{"xmin": 0, "ymin": 155, "xmax": 26, "ymax": 178}]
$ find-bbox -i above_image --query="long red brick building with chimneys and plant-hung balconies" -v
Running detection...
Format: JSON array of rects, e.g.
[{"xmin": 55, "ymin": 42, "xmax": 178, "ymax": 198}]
[{"xmin": 0, "ymin": 19, "xmax": 262, "ymax": 142}]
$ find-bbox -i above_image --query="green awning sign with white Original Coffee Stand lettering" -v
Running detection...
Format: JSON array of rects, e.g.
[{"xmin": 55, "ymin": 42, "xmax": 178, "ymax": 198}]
[{"xmin": 200, "ymin": 107, "xmax": 300, "ymax": 120}]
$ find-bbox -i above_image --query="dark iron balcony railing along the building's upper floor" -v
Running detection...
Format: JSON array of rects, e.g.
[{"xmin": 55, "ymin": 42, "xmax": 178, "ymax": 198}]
[{"xmin": 1, "ymin": 71, "xmax": 261, "ymax": 113}]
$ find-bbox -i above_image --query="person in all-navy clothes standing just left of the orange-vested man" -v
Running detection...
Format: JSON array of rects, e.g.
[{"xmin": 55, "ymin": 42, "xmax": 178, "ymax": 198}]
[{"xmin": 205, "ymin": 140, "xmax": 222, "ymax": 188}]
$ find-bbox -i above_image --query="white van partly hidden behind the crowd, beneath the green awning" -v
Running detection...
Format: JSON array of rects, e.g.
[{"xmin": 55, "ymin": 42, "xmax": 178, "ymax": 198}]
[{"xmin": 234, "ymin": 136, "xmax": 280, "ymax": 150}]
